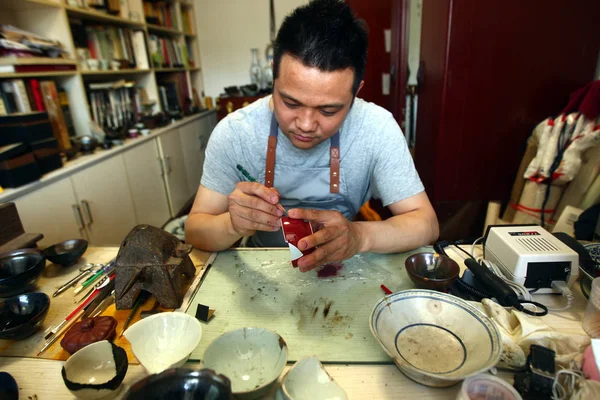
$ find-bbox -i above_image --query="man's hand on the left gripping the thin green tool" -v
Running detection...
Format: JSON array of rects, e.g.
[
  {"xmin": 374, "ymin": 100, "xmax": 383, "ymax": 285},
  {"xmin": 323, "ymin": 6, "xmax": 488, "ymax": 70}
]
[{"xmin": 228, "ymin": 182, "xmax": 283, "ymax": 236}]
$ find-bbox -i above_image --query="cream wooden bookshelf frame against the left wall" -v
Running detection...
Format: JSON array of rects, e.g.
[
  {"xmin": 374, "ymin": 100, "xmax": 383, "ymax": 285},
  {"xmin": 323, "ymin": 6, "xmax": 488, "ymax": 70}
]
[{"xmin": 0, "ymin": 0, "xmax": 204, "ymax": 136}]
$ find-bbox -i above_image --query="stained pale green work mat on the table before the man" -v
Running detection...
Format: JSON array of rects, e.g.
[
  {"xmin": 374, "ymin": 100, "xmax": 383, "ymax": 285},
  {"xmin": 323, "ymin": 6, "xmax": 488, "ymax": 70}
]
[{"xmin": 187, "ymin": 248, "xmax": 431, "ymax": 363}]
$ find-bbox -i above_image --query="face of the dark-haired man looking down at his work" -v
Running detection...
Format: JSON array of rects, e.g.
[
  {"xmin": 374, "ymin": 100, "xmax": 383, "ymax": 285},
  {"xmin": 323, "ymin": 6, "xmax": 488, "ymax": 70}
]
[{"xmin": 273, "ymin": 54, "xmax": 362, "ymax": 150}]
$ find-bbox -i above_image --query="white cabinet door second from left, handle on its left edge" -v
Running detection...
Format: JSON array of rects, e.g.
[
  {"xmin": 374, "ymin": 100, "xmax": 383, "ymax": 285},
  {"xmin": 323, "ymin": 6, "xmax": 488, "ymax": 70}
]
[{"xmin": 71, "ymin": 154, "xmax": 136, "ymax": 246}]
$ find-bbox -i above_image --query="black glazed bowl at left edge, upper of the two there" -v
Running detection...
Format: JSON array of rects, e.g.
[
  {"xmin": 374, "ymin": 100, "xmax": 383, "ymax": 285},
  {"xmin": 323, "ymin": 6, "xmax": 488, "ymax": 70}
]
[{"xmin": 0, "ymin": 249, "xmax": 46, "ymax": 297}]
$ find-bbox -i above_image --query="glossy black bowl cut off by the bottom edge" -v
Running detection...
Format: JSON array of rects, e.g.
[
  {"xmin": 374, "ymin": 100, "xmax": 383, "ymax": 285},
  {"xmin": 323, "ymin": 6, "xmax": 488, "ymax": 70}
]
[{"xmin": 123, "ymin": 368, "xmax": 233, "ymax": 400}]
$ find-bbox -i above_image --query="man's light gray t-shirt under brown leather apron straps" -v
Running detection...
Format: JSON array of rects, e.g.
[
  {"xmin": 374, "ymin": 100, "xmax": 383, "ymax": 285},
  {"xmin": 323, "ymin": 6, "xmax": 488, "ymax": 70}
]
[{"xmin": 201, "ymin": 96, "xmax": 424, "ymax": 219}]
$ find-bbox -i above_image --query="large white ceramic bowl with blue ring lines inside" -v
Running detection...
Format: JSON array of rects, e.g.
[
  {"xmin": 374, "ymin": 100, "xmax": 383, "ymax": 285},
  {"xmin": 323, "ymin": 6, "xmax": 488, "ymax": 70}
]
[{"xmin": 369, "ymin": 290, "xmax": 502, "ymax": 387}]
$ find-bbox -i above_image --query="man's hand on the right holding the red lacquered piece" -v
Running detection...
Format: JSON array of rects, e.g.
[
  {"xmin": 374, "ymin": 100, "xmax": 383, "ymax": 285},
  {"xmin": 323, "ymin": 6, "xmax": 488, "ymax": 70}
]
[{"xmin": 288, "ymin": 208, "xmax": 362, "ymax": 272}]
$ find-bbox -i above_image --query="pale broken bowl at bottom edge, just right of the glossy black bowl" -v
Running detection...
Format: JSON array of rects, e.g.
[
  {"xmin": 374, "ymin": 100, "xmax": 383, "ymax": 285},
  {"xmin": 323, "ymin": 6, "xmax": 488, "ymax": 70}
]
[{"xmin": 276, "ymin": 356, "xmax": 348, "ymax": 400}]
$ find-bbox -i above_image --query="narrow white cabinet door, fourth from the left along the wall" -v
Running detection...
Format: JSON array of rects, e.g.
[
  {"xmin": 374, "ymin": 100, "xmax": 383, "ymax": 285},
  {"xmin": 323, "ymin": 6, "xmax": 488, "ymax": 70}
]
[{"xmin": 157, "ymin": 129, "xmax": 193, "ymax": 216}]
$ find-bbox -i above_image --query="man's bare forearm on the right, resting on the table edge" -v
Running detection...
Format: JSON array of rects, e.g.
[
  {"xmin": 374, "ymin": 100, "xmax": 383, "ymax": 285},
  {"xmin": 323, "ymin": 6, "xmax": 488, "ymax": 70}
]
[{"xmin": 354, "ymin": 210, "xmax": 439, "ymax": 253}]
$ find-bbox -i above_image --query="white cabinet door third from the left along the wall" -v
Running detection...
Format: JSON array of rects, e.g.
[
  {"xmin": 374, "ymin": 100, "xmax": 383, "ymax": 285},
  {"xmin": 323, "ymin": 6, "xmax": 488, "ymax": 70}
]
[{"xmin": 123, "ymin": 140, "xmax": 171, "ymax": 228}]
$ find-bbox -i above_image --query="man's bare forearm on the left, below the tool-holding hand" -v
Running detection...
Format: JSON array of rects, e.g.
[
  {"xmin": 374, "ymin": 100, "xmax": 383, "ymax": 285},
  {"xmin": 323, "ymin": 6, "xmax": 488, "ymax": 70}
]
[{"xmin": 185, "ymin": 212, "xmax": 241, "ymax": 251}]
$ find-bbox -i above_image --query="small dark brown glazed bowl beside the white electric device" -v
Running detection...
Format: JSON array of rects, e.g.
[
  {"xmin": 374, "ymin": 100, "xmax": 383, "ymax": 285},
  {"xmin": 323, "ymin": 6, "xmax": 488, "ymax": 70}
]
[{"xmin": 404, "ymin": 253, "xmax": 460, "ymax": 292}]
